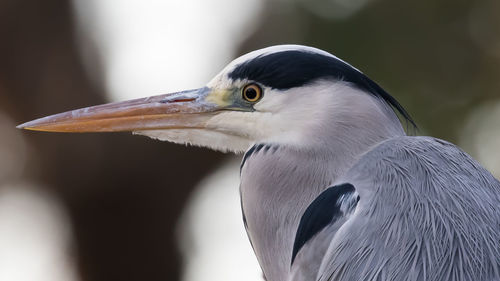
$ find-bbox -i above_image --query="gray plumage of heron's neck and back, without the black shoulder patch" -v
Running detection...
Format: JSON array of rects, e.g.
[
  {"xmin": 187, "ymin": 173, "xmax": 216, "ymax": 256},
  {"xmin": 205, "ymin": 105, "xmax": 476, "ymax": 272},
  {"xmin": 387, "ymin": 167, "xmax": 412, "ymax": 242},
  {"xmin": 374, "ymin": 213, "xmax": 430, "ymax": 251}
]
[{"xmin": 235, "ymin": 47, "xmax": 500, "ymax": 281}]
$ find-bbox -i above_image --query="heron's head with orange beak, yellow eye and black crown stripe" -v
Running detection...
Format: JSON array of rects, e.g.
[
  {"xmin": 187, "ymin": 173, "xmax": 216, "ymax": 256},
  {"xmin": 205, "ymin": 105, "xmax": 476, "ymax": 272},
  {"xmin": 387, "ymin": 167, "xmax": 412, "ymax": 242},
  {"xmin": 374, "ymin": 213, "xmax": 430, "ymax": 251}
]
[{"xmin": 18, "ymin": 45, "xmax": 412, "ymax": 152}]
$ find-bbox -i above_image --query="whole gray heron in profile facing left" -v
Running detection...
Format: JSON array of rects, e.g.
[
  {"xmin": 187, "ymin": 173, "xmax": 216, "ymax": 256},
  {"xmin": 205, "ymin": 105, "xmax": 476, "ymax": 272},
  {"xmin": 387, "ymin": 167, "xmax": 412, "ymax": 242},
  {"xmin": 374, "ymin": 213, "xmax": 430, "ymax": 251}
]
[{"xmin": 19, "ymin": 45, "xmax": 500, "ymax": 281}]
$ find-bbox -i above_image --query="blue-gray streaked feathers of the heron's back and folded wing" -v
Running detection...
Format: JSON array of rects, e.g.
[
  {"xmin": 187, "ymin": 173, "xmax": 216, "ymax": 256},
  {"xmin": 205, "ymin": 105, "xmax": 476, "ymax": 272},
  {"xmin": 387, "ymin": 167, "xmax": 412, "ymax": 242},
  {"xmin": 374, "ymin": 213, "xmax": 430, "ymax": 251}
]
[{"xmin": 320, "ymin": 137, "xmax": 500, "ymax": 281}]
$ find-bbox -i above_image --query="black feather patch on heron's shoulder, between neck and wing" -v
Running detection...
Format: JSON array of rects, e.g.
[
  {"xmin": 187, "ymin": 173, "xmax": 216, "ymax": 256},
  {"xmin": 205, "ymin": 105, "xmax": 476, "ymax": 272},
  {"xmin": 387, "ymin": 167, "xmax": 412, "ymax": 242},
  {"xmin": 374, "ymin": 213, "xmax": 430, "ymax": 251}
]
[{"xmin": 292, "ymin": 183, "xmax": 359, "ymax": 264}]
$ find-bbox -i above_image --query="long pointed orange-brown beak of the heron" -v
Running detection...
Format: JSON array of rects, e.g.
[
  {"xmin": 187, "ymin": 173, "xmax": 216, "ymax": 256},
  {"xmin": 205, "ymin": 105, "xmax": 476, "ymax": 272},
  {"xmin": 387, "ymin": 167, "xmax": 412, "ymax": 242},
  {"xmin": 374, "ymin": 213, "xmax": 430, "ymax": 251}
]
[{"xmin": 17, "ymin": 87, "xmax": 220, "ymax": 133}]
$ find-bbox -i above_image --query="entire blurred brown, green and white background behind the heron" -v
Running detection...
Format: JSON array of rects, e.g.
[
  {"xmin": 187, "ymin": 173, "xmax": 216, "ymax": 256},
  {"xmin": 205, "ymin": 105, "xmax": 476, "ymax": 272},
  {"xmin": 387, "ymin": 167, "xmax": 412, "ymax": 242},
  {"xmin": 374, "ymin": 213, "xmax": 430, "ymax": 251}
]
[{"xmin": 0, "ymin": 0, "xmax": 500, "ymax": 281}]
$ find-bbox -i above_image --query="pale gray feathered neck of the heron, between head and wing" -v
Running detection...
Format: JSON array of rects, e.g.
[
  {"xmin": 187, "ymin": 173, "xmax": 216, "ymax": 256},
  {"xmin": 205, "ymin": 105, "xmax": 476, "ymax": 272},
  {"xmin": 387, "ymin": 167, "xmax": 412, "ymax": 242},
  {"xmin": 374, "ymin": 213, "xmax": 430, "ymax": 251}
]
[{"xmin": 240, "ymin": 85, "xmax": 405, "ymax": 281}]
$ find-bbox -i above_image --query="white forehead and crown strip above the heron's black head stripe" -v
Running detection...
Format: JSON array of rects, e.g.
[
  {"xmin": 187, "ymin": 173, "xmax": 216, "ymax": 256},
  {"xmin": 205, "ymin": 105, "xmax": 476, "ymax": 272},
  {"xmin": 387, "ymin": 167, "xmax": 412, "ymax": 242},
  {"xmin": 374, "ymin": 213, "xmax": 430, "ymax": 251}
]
[{"xmin": 207, "ymin": 44, "xmax": 354, "ymax": 87}]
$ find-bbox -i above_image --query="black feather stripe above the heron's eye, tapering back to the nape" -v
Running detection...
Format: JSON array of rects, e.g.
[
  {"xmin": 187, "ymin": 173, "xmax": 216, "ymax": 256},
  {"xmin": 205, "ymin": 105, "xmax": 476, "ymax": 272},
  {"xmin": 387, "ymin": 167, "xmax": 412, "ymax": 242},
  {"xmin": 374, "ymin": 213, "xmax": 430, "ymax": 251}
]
[{"xmin": 228, "ymin": 50, "xmax": 416, "ymax": 128}]
